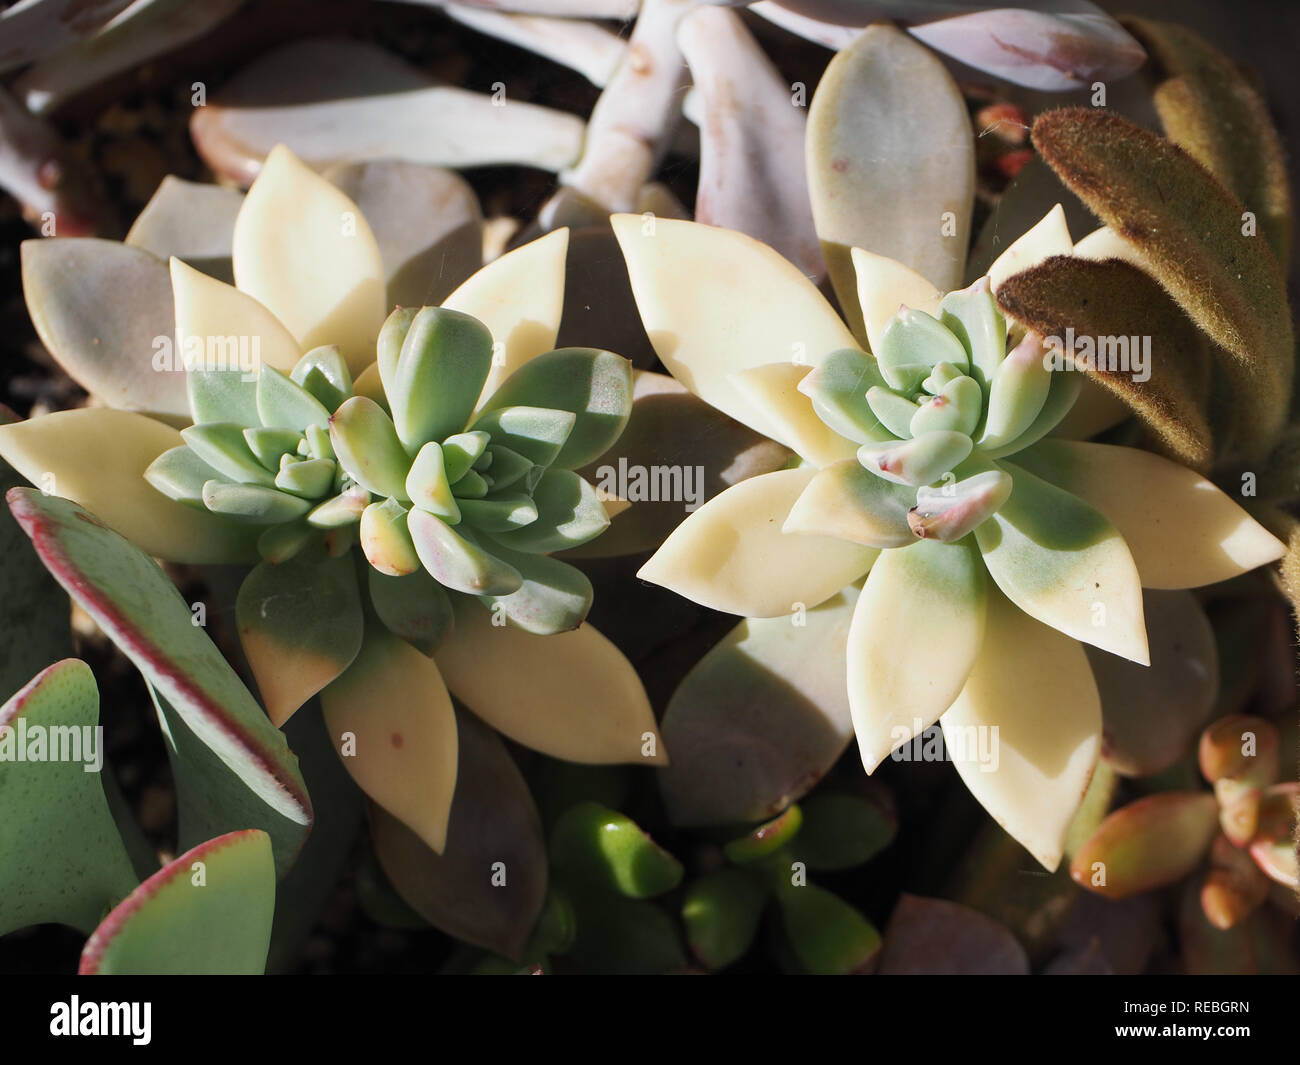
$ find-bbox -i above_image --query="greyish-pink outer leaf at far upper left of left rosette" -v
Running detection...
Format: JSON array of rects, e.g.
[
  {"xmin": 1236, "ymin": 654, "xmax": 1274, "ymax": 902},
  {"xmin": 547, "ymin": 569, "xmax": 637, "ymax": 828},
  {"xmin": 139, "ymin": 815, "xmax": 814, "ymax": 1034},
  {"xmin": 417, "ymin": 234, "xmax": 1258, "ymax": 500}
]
[{"xmin": 22, "ymin": 238, "xmax": 189, "ymax": 416}]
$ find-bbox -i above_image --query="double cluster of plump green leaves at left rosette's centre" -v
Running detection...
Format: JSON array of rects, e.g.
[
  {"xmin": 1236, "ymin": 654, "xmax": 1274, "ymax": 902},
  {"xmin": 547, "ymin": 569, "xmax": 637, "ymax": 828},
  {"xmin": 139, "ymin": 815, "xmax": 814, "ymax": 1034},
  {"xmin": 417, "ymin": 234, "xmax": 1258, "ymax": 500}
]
[{"xmin": 146, "ymin": 300, "xmax": 631, "ymax": 632}]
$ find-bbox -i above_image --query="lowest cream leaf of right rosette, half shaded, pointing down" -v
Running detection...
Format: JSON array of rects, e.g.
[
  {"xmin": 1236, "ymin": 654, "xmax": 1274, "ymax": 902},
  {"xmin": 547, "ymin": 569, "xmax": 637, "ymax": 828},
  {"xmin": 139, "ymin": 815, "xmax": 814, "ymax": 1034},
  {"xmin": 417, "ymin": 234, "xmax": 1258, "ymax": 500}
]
[{"xmin": 940, "ymin": 589, "xmax": 1101, "ymax": 871}]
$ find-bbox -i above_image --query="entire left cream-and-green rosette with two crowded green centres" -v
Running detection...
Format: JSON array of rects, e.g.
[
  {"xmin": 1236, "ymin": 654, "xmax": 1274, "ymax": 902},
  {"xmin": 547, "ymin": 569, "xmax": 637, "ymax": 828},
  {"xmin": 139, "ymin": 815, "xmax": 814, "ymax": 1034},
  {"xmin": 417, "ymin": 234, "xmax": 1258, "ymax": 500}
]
[{"xmin": 0, "ymin": 148, "xmax": 664, "ymax": 852}]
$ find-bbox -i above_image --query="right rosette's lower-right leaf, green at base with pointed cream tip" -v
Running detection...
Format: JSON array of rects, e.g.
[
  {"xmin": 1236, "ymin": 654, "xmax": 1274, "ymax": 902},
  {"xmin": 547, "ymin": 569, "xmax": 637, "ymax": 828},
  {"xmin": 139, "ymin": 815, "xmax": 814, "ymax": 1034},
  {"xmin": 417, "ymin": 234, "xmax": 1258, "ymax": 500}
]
[{"xmin": 975, "ymin": 463, "xmax": 1151, "ymax": 666}]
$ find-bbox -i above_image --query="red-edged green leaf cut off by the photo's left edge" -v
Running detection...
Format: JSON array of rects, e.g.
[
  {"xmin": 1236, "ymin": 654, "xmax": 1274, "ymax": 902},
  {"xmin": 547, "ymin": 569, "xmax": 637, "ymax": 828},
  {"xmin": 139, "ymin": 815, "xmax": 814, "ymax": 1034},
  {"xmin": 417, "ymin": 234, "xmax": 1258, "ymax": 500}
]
[{"xmin": 0, "ymin": 658, "xmax": 137, "ymax": 935}]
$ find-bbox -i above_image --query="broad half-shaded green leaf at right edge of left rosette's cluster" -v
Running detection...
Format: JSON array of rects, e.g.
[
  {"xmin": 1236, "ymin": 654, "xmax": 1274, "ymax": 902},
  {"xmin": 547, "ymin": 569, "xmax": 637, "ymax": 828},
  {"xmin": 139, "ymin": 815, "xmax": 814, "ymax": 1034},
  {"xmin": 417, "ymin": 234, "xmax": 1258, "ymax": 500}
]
[{"xmin": 485, "ymin": 347, "xmax": 632, "ymax": 469}]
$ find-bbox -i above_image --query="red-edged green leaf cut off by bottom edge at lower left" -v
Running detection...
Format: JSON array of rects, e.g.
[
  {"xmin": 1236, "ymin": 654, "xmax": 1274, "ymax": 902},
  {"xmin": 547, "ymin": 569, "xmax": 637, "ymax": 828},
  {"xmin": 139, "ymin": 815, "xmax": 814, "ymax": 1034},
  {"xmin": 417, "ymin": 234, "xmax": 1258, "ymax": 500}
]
[{"xmin": 78, "ymin": 828, "xmax": 276, "ymax": 977}]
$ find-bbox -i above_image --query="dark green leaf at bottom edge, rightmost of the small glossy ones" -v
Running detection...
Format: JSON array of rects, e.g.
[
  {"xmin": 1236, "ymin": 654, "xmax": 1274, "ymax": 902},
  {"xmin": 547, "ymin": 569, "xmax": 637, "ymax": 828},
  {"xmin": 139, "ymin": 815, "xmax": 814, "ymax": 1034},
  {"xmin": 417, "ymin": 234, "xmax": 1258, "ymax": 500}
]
[{"xmin": 776, "ymin": 874, "xmax": 880, "ymax": 975}]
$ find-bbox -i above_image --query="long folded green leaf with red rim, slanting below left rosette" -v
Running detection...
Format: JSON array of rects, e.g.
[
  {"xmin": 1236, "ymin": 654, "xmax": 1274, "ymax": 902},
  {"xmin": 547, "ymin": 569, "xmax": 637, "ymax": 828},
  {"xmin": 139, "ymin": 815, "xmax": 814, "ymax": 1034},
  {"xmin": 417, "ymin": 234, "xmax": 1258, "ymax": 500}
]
[{"xmin": 7, "ymin": 488, "xmax": 312, "ymax": 871}]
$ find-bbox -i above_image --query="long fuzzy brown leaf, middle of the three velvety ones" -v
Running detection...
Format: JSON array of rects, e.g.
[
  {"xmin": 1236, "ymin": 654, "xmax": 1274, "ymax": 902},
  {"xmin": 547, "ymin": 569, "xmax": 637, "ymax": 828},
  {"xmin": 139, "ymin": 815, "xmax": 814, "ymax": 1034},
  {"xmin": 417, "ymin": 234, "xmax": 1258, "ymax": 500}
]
[{"xmin": 1034, "ymin": 108, "xmax": 1294, "ymax": 454}]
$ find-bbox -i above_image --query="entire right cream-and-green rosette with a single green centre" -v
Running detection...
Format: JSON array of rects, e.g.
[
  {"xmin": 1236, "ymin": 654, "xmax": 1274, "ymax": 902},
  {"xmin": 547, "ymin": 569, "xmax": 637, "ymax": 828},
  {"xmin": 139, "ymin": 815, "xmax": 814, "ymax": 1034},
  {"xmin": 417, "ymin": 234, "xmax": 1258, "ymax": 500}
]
[{"xmin": 614, "ymin": 207, "xmax": 1283, "ymax": 869}]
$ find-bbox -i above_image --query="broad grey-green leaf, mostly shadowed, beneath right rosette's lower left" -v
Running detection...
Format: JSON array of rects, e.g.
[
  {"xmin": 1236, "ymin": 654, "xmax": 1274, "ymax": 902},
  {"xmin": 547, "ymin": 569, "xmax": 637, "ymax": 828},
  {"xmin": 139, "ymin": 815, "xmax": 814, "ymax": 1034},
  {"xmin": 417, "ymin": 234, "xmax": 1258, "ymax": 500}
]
[{"xmin": 659, "ymin": 588, "xmax": 857, "ymax": 826}]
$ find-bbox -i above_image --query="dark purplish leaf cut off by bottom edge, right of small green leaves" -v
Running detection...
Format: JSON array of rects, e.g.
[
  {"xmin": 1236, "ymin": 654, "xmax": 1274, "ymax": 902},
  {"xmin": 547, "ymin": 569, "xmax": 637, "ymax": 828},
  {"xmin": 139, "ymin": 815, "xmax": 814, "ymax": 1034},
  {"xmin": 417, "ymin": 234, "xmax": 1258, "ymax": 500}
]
[{"xmin": 876, "ymin": 893, "xmax": 1030, "ymax": 977}]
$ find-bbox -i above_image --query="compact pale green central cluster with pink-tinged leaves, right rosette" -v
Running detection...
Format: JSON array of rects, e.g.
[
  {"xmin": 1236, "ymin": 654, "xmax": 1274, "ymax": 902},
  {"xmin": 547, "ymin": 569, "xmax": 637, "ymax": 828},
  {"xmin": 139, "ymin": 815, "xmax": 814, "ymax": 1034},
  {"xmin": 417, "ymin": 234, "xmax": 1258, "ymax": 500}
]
[{"xmin": 792, "ymin": 277, "xmax": 1079, "ymax": 547}]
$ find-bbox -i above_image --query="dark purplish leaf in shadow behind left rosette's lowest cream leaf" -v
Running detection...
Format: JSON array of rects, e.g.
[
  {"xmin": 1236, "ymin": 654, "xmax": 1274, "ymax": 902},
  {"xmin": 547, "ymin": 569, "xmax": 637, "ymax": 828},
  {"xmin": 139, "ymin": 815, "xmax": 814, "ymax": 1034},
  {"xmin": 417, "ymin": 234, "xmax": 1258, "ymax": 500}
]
[{"xmin": 371, "ymin": 711, "xmax": 546, "ymax": 960}]
